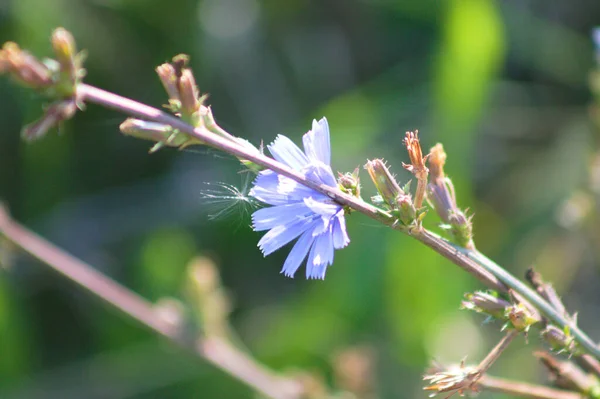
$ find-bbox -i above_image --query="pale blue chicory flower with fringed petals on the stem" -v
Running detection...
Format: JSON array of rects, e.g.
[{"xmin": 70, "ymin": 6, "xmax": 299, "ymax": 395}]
[{"xmin": 250, "ymin": 118, "xmax": 350, "ymax": 279}]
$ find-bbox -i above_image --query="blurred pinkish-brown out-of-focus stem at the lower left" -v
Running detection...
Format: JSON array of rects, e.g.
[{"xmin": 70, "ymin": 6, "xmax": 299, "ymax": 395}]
[{"xmin": 0, "ymin": 205, "xmax": 302, "ymax": 399}]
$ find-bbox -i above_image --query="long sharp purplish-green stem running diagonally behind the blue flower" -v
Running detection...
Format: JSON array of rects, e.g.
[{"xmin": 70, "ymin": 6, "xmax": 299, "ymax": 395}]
[{"xmin": 77, "ymin": 84, "xmax": 600, "ymax": 359}]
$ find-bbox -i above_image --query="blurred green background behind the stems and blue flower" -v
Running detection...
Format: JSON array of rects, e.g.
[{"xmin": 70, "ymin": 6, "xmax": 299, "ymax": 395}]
[{"xmin": 0, "ymin": 0, "xmax": 600, "ymax": 399}]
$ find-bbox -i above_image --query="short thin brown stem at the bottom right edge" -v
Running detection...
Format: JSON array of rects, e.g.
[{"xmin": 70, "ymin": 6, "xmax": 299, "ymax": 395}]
[{"xmin": 477, "ymin": 375, "xmax": 585, "ymax": 399}]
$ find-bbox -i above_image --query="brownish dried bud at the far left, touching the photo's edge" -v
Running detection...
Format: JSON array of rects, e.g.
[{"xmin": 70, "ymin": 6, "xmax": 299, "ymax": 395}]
[{"xmin": 0, "ymin": 42, "xmax": 54, "ymax": 89}]
